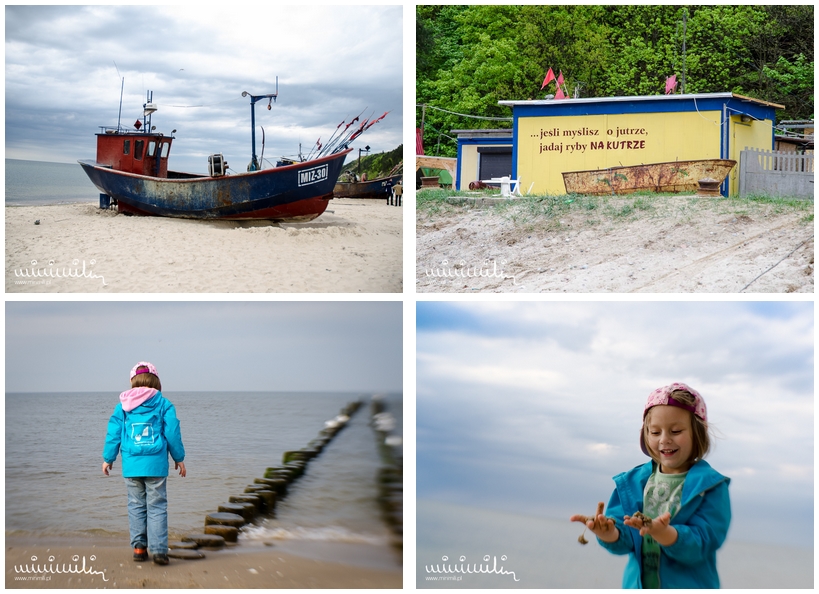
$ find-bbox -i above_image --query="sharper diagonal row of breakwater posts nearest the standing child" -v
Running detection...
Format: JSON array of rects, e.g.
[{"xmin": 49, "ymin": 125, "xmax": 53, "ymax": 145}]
[{"xmin": 168, "ymin": 401, "xmax": 362, "ymax": 559}]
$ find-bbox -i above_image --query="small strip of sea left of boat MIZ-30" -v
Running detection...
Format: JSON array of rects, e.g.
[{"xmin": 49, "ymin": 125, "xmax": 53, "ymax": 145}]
[{"xmin": 6, "ymin": 159, "xmax": 100, "ymax": 206}]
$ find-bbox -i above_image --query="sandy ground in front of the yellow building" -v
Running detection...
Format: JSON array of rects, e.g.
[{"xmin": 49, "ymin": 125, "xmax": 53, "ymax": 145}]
[{"xmin": 416, "ymin": 196, "xmax": 814, "ymax": 293}]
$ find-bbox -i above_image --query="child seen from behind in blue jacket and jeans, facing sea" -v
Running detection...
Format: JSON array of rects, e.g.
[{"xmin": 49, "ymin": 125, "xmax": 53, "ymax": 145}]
[{"xmin": 102, "ymin": 361, "xmax": 187, "ymax": 565}]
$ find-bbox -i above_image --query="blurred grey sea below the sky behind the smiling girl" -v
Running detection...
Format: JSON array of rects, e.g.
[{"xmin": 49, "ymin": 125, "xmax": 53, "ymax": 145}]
[{"xmin": 416, "ymin": 500, "xmax": 813, "ymax": 589}]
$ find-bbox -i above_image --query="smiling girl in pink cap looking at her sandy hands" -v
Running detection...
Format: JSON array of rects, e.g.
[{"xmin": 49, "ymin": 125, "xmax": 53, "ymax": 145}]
[{"xmin": 570, "ymin": 383, "xmax": 731, "ymax": 588}]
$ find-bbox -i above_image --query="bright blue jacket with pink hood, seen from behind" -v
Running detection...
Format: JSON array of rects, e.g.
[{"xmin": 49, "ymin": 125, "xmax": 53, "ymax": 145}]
[{"xmin": 102, "ymin": 388, "xmax": 185, "ymax": 477}]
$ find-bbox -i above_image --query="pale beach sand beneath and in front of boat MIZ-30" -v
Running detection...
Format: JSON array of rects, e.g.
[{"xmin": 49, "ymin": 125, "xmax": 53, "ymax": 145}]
[{"xmin": 5, "ymin": 199, "xmax": 404, "ymax": 293}]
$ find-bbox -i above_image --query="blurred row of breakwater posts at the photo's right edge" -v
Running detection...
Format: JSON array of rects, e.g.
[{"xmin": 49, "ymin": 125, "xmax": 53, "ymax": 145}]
[{"xmin": 371, "ymin": 396, "xmax": 404, "ymax": 551}]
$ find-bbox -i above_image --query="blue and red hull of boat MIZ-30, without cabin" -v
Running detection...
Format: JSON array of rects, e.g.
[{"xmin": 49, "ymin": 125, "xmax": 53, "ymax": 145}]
[{"xmin": 79, "ymin": 149, "xmax": 352, "ymax": 221}]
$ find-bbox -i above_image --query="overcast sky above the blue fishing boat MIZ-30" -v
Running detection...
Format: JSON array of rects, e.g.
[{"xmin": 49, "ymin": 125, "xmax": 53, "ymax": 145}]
[{"xmin": 5, "ymin": 3, "xmax": 403, "ymax": 172}]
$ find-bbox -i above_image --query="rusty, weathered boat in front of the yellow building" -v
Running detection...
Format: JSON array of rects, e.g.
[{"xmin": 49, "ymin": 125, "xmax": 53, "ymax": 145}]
[{"xmin": 563, "ymin": 159, "xmax": 737, "ymax": 196}]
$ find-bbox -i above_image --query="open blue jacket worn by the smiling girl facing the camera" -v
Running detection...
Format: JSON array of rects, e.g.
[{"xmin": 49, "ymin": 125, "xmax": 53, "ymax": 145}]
[{"xmin": 597, "ymin": 460, "xmax": 731, "ymax": 588}]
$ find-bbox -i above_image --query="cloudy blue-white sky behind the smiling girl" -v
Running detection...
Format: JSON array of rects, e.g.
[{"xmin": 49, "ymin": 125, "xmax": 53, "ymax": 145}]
[{"xmin": 416, "ymin": 302, "xmax": 814, "ymax": 546}]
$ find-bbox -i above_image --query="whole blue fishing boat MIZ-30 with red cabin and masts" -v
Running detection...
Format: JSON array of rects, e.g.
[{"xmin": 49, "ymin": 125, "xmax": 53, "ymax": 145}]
[{"xmin": 79, "ymin": 83, "xmax": 386, "ymax": 221}]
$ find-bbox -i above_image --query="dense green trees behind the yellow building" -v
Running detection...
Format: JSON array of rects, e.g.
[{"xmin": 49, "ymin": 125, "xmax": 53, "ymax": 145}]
[{"xmin": 416, "ymin": 5, "xmax": 814, "ymax": 156}]
